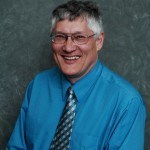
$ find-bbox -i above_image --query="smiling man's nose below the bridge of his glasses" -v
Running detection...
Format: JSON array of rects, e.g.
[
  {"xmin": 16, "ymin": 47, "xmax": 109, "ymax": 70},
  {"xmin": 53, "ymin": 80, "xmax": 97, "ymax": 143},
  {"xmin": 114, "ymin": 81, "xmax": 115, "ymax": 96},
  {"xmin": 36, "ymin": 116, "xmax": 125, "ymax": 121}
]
[{"xmin": 63, "ymin": 36, "xmax": 76, "ymax": 52}]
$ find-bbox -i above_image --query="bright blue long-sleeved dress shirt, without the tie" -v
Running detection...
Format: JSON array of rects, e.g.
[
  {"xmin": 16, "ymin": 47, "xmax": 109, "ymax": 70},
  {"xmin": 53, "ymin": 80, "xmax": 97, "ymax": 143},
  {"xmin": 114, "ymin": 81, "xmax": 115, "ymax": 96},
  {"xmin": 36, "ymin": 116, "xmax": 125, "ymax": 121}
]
[{"xmin": 7, "ymin": 61, "xmax": 146, "ymax": 150}]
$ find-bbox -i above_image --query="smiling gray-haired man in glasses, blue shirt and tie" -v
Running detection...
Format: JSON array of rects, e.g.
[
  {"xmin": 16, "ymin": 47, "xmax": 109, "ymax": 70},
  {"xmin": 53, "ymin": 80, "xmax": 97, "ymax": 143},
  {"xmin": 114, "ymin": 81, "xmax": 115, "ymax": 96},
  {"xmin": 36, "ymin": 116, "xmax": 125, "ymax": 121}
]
[{"xmin": 7, "ymin": 1, "xmax": 146, "ymax": 150}]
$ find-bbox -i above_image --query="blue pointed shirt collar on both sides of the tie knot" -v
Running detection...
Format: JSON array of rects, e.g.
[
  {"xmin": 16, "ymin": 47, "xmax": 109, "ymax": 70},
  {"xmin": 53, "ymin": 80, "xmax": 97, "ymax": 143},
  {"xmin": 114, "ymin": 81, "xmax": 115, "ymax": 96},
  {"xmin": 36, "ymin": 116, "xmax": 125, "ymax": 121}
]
[{"xmin": 62, "ymin": 60, "xmax": 102, "ymax": 102}]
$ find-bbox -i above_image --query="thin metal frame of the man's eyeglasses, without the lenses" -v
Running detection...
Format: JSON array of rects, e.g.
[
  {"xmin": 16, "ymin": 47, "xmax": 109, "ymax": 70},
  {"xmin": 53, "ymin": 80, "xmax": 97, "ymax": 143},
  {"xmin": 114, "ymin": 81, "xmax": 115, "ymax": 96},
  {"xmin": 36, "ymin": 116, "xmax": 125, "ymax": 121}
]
[{"xmin": 50, "ymin": 33, "xmax": 97, "ymax": 45}]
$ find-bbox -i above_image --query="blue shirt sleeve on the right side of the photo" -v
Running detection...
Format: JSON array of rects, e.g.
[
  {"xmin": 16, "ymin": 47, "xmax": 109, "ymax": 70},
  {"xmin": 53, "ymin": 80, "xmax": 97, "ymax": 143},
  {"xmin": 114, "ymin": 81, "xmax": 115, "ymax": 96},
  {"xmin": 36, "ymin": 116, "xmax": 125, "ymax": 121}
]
[{"xmin": 106, "ymin": 98, "xmax": 146, "ymax": 150}]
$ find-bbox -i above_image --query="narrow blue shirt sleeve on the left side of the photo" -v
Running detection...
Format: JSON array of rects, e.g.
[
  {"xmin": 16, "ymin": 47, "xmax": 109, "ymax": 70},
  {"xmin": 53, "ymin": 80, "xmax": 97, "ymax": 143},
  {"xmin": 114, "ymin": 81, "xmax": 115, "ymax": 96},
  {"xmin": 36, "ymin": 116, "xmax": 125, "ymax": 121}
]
[{"xmin": 6, "ymin": 82, "xmax": 32, "ymax": 150}]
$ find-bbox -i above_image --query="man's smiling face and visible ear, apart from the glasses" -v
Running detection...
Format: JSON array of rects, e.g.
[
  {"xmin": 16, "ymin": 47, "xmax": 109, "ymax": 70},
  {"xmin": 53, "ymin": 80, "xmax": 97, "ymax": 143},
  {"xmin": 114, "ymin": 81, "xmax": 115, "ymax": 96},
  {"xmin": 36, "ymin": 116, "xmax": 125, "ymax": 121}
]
[{"xmin": 52, "ymin": 18, "xmax": 104, "ymax": 83}]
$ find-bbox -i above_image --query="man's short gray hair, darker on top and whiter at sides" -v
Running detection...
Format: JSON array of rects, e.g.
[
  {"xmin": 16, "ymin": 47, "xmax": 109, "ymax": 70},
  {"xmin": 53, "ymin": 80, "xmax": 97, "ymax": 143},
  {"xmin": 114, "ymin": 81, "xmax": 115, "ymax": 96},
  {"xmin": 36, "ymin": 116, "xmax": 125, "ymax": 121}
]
[{"xmin": 51, "ymin": 0, "xmax": 103, "ymax": 35}]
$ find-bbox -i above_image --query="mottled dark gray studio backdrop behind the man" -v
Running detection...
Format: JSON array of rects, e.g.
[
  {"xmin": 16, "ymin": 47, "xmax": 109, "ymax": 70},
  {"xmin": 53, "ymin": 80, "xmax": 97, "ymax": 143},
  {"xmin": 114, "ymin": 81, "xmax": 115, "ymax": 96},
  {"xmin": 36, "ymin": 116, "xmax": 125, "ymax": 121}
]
[{"xmin": 0, "ymin": 0, "xmax": 150, "ymax": 150}]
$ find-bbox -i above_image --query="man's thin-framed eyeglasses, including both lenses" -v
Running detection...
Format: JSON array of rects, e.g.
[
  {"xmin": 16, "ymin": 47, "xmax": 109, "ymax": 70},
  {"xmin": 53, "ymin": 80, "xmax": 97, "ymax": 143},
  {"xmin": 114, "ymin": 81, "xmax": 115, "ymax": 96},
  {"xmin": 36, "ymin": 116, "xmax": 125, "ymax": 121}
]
[{"xmin": 51, "ymin": 33, "xmax": 96, "ymax": 45}]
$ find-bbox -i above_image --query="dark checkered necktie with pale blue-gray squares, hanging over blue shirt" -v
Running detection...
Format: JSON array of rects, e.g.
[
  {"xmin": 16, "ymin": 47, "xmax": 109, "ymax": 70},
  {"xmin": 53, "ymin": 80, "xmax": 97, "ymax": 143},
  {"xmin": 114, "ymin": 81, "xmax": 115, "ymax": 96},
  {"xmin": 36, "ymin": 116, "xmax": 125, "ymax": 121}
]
[{"xmin": 50, "ymin": 87, "xmax": 76, "ymax": 150}]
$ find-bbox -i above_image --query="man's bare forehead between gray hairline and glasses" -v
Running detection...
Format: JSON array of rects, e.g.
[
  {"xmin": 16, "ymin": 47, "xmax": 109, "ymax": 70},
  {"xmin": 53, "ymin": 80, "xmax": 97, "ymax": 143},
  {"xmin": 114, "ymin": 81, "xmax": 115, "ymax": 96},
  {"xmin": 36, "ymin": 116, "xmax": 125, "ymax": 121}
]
[{"xmin": 54, "ymin": 18, "xmax": 92, "ymax": 33}]
